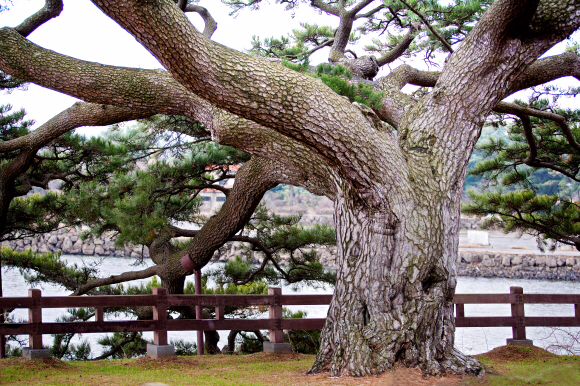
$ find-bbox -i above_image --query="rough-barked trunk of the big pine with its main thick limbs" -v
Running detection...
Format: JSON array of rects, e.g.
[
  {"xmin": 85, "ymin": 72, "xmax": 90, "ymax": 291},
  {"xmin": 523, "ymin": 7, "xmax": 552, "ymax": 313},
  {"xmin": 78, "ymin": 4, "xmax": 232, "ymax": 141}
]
[{"xmin": 0, "ymin": 0, "xmax": 580, "ymax": 376}]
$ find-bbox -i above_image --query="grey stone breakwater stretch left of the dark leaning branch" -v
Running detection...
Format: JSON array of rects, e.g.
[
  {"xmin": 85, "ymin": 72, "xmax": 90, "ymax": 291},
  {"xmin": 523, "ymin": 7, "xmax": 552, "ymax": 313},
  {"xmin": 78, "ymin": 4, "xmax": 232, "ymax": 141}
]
[{"xmin": 2, "ymin": 229, "xmax": 149, "ymax": 258}]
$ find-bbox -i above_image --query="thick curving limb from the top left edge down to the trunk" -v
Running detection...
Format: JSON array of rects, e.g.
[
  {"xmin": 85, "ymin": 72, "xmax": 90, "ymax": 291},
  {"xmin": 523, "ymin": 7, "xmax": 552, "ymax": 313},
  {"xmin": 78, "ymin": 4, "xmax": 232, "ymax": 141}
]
[{"xmin": 93, "ymin": 0, "xmax": 404, "ymax": 195}]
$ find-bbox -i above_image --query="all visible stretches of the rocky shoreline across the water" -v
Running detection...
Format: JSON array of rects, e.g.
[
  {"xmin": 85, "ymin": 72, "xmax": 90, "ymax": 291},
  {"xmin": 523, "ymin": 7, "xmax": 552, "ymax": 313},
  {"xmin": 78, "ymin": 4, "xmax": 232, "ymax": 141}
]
[{"xmin": 2, "ymin": 229, "xmax": 580, "ymax": 281}]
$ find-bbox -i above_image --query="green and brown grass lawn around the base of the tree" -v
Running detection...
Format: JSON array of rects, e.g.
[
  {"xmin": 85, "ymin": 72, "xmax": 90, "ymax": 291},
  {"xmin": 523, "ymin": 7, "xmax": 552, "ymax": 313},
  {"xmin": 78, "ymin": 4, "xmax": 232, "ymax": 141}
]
[{"xmin": 0, "ymin": 346, "xmax": 580, "ymax": 386}]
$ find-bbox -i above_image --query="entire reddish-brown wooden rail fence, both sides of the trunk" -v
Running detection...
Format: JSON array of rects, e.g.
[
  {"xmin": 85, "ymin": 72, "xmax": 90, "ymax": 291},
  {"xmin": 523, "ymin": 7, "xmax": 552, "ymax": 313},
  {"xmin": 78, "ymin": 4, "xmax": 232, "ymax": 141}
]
[{"xmin": 0, "ymin": 287, "xmax": 580, "ymax": 354}]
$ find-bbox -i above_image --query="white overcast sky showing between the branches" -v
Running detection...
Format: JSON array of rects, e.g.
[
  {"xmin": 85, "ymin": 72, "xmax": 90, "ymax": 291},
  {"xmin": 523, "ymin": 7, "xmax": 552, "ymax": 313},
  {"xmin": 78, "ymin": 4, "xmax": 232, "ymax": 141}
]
[{"xmin": 0, "ymin": 0, "xmax": 337, "ymax": 134}]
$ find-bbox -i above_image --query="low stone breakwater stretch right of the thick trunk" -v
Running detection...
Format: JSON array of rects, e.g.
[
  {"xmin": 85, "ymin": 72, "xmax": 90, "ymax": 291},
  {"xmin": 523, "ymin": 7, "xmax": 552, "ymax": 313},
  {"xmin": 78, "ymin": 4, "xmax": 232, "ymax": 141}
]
[{"xmin": 457, "ymin": 251, "xmax": 580, "ymax": 281}]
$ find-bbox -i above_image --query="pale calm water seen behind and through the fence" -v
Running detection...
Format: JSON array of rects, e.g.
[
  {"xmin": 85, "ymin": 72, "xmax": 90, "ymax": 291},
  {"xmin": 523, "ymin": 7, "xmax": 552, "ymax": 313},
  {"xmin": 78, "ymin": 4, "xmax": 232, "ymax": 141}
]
[{"xmin": 2, "ymin": 256, "xmax": 580, "ymax": 356}]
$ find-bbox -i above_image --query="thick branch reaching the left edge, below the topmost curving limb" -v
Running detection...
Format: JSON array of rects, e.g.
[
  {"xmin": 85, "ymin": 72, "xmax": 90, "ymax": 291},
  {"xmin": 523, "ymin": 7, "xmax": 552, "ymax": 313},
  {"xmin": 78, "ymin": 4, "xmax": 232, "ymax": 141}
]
[{"xmin": 0, "ymin": 27, "xmax": 212, "ymax": 127}]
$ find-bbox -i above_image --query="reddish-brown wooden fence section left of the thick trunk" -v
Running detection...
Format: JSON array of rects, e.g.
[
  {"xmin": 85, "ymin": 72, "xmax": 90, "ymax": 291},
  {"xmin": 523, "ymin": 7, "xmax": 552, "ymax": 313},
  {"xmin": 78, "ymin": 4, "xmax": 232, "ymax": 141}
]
[{"xmin": 0, "ymin": 287, "xmax": 332, "ymax": 358}]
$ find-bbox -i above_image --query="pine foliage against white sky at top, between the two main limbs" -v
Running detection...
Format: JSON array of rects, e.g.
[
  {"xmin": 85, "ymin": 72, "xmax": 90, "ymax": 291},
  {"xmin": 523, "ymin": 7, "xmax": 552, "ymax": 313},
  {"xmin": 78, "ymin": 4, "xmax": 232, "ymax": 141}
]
[{"xmin": 222, "ymin": 0, "xmax": 492, "ymax": 63}]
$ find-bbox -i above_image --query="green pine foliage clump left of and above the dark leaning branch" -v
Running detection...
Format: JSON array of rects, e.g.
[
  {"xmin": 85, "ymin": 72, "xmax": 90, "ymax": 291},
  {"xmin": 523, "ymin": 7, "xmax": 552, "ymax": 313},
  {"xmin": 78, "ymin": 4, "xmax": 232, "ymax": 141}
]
[{"xmin": 64, "ymin": 128, "xmax": 248, "ymax": 245}]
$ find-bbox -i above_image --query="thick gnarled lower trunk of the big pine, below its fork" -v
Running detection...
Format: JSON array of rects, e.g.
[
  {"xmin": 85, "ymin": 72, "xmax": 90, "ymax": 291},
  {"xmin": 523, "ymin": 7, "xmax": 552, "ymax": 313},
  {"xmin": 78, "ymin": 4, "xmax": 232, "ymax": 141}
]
[{"xmin": 310, "ymin": 185, "xmax": 481, "ymax": 376}]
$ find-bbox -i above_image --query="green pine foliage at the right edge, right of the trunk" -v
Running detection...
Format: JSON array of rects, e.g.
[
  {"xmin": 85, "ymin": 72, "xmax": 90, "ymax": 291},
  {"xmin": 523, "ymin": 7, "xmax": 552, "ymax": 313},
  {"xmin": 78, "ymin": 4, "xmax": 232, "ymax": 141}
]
[{"xmin": 462, "ymin": 99, "xmax": 580, "ymax": 249}]
